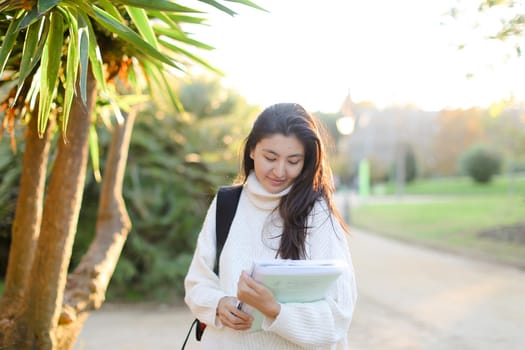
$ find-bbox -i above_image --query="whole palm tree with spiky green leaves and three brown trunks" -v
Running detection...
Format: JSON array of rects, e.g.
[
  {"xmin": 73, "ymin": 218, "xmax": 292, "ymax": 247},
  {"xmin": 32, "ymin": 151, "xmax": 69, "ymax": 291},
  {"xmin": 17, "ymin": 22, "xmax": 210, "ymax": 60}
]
[{"xmin": 0, "ymin": 0, "xmax": 259, "ymax": 350}]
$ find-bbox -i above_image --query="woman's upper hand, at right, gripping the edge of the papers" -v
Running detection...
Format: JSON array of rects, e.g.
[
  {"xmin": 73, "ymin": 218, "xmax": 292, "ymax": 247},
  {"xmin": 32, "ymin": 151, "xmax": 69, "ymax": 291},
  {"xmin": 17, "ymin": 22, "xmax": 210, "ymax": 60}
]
[{"xmin": 237, "ymin": 271, "xmax": 281, "ymax": 318}]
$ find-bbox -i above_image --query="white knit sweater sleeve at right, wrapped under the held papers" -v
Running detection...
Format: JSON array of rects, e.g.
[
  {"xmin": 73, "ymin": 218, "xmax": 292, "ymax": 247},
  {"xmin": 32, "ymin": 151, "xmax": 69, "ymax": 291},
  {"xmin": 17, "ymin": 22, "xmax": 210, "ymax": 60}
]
[{"xmin": 263, "ymin": 201, "xmax": 357, "ymax": 346}]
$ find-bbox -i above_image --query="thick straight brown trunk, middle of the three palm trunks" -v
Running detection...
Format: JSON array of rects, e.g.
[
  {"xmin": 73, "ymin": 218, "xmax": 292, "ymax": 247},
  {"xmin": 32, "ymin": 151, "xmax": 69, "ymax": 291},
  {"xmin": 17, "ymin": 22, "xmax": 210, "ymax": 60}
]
[{"xmin": 6, "ymin": 69, "xmax": 96, "ymax": 350}]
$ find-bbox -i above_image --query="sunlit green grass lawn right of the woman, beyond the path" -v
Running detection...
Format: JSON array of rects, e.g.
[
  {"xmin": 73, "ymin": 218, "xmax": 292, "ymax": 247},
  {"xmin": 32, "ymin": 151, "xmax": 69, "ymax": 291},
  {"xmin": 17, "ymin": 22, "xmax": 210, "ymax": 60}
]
[{"xmin": 352, "ymin": 174, "xmax": 525, "ymax": 268}]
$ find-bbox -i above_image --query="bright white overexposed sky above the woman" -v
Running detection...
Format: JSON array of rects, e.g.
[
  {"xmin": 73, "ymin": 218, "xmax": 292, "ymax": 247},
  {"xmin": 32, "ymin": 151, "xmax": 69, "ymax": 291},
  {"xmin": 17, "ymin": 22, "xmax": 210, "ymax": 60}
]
[{"xmin": 186, "ymin": 0, "xmax": 525, "ymax": 113}]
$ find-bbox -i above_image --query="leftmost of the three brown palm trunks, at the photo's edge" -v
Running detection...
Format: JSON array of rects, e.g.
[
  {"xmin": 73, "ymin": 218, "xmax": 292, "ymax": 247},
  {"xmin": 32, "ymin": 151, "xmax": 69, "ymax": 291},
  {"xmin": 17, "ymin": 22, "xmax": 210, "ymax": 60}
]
[{"xmin": 0, "ymin": 107, "xmax": 54, "ymax": 338}]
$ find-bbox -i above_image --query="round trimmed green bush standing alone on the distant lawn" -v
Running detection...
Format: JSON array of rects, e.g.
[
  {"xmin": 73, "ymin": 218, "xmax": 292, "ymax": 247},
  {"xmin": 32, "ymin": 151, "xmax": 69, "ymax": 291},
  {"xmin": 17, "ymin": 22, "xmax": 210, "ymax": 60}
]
[{"xmin": 459, "ymin": 144, "xmax": 502, "ymax": 183}]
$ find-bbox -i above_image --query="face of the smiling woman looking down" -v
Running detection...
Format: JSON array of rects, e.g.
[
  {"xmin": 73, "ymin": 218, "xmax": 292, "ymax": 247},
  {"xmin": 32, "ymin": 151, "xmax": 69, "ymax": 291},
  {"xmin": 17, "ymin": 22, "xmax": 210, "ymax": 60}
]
[{"xmin": 250, "ymin": 134, "xmax": 304, "ymax": 193}]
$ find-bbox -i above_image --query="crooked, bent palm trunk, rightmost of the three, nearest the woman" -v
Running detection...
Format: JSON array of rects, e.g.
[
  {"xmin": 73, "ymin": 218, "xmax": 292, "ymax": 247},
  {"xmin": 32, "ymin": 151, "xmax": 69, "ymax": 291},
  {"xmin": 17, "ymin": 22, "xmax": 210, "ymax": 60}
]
[{"xmin": 57, "ymin": 111, "xmax": 136, "ymax": 350}]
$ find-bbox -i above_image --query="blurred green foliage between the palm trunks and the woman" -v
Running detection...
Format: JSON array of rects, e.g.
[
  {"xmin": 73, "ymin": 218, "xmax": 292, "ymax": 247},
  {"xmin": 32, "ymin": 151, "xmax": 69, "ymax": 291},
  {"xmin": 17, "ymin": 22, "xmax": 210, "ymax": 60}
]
[{"xmin": 72, "ymin": 86, "xmax": 255, "ymax": 301}]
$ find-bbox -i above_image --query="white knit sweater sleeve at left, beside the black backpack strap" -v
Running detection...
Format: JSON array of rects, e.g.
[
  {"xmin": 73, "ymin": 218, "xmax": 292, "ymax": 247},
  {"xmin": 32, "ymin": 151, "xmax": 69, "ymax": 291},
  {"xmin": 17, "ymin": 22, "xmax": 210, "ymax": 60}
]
[{"xmin": 184, "ymin": 197, "xmax": 226, "ymax": 327}]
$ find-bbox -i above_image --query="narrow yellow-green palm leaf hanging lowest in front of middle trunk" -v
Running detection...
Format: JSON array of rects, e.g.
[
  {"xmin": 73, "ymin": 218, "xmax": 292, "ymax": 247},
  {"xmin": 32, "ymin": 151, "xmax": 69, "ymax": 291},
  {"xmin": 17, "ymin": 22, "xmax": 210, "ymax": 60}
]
[{"xmin": 62, "ymin": 8, "xmax": 80, "ymax": 140}]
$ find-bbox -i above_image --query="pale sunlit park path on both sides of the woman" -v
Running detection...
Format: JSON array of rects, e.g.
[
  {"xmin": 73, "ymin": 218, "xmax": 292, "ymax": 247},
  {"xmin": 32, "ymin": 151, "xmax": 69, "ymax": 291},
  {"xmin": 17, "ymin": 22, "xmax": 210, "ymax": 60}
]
[{"xmin": 75, "ymin": 229, "xmax": 525, "ymax": 350}]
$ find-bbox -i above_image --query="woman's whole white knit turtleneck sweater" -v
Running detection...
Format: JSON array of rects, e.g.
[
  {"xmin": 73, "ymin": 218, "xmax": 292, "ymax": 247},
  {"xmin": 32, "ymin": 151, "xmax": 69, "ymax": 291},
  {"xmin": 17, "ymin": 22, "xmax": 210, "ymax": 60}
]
[{"xmin": 184, "ymin": 174, "xmax": 357, "ymax": 350}]
